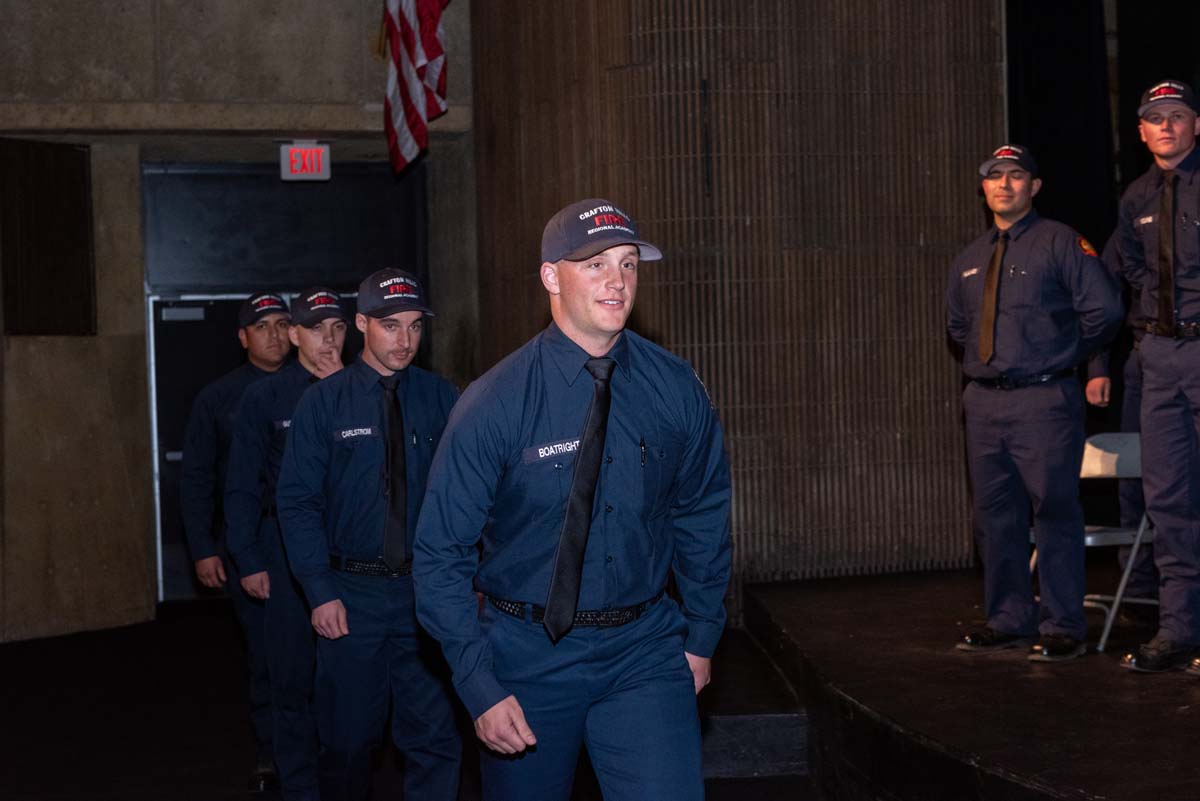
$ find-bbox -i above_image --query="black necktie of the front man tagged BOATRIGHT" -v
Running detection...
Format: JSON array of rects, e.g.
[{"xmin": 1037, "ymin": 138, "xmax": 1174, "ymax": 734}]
[{"xmin": 542, "ymin": 359, "xmax": 617, "ymax": 643}]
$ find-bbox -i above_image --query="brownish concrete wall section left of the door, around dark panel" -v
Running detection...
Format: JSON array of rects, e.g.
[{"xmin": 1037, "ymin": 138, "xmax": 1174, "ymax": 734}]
[{"xmin": 0, "ymin": 145, "xmax": 155, "ymax": 639}]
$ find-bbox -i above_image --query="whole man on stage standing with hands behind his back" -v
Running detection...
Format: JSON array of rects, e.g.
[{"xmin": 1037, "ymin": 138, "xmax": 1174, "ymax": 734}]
[{"xmin": 947, "ymin": 145, "xmax": 1122, "ymax": 662}]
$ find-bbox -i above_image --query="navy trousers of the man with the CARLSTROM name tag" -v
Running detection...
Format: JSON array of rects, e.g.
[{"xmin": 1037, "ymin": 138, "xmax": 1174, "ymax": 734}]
[{"xmin": 317, "ymin": 572, "xmax": 462, "ymax": 801}]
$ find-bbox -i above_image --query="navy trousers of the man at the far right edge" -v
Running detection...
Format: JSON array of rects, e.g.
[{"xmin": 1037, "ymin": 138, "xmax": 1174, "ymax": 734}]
[{"xmin": 1141, "ymin": 333, "xmax": 1200, "ymax": 645}]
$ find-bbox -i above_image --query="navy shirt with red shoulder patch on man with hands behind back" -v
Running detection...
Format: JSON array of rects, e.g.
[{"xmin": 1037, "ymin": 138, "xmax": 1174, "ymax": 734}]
[{"xmin": 946, "ymin": 210, "xmax": 1124, "ymax": 379}]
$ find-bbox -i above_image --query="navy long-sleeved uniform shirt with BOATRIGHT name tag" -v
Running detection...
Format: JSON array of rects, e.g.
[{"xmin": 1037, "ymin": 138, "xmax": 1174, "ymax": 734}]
[{"xmin": 413, "ymin": 324, "xmax": 731, "ymax": 718}]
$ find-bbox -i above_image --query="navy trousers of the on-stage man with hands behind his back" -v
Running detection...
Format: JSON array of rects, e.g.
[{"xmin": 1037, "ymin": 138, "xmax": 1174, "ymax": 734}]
[{"xmin": 962, "ymin": 379, "xmax": 1087, "ymax": 640}]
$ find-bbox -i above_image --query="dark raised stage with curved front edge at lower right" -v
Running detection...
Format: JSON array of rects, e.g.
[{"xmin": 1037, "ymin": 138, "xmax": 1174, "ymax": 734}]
[{"xmin": 745, "ymin": 570, "xmax": 1200, "ymax": 801}]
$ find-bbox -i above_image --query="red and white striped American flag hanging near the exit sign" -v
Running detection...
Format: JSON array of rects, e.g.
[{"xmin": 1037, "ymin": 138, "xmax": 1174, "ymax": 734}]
[{"xmin": 383, "ymin": 0, "xmax": 446, "ymax": 173}]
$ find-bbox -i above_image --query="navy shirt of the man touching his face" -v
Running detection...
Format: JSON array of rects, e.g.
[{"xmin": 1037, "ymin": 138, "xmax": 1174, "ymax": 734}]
[{"xmin": 224, "ymin": 361, "xmax": 317, "ymax": 576}]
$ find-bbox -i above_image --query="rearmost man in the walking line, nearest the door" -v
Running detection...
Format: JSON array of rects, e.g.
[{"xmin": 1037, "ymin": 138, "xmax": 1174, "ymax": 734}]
[{"xmin": 179, "ymin": 293, "xmax": 290, "ymax": 793}]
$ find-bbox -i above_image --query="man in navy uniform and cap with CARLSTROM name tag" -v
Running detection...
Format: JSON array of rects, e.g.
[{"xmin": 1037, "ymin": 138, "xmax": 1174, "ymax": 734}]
[{"xmin": 276, "ymin": 270, "xmax": 462, "ymax": 801}]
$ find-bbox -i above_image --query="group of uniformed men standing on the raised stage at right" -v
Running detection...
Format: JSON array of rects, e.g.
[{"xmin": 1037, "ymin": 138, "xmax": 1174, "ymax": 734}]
[{"xmin": 947, "ymin": 80, "xmax": 1200, "ymax": 675}]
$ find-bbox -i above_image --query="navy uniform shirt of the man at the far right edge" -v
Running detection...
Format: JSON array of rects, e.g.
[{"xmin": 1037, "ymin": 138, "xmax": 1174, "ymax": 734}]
[{"xmin": 1116, "ymin": 147, "xmax": 1200, "ymax": 323}]
